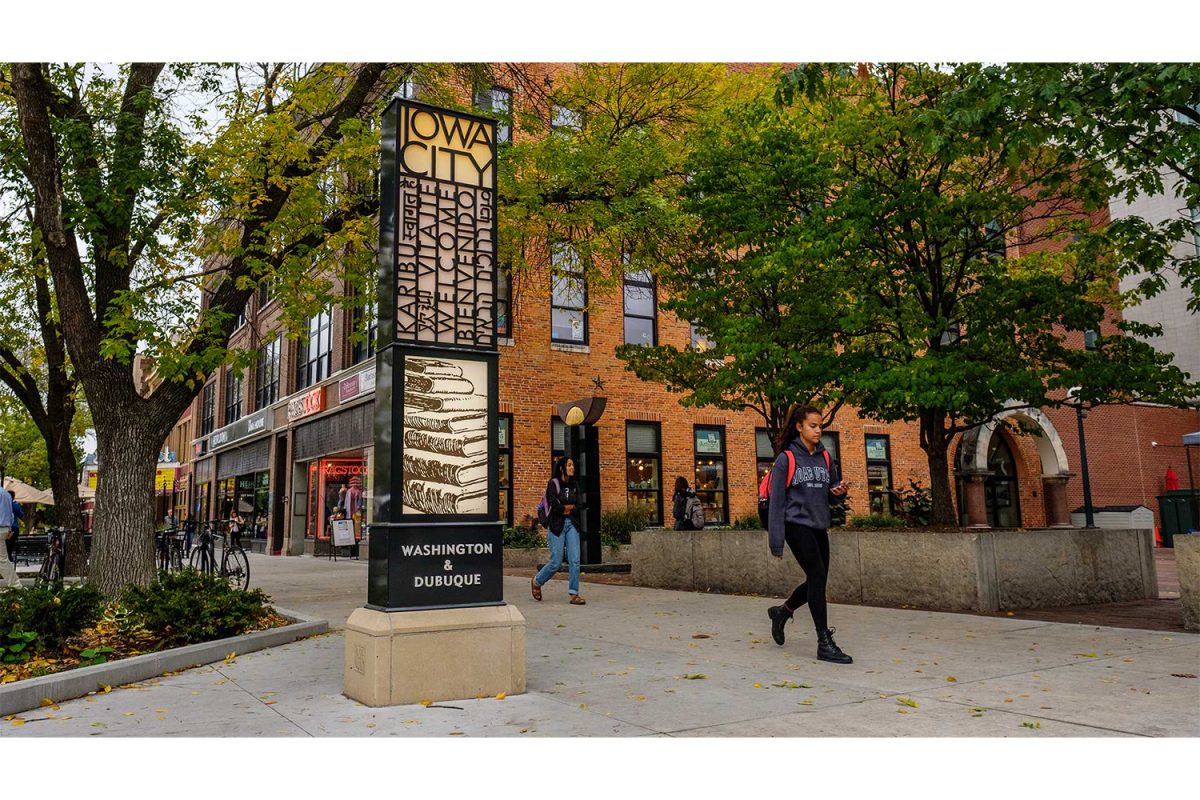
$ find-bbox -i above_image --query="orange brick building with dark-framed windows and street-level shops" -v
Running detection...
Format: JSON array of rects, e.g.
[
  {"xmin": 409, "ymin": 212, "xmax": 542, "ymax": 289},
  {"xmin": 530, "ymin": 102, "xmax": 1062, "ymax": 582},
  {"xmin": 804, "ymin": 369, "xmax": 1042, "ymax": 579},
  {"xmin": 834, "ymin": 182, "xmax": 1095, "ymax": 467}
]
[{"xmin": 181, "ymin": 64, "xmax": 1200, "ymax": 554}]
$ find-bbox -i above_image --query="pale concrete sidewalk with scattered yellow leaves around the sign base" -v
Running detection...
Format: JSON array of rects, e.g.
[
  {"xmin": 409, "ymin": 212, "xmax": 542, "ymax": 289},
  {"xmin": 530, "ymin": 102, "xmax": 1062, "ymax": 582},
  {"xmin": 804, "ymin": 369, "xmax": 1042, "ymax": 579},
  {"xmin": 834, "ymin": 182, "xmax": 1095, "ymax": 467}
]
[{"xmin": 0, "ymin": 557, "xmax": 1200, "ymax": 736}]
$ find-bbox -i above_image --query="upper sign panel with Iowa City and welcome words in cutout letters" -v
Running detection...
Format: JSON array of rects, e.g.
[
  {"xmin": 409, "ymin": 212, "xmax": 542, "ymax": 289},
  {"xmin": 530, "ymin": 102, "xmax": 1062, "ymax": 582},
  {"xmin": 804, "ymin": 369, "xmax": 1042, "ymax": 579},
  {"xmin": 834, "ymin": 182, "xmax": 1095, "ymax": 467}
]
[{"xmin": 396, "ymin": 101, "xmax": 496, "ymax": 348}]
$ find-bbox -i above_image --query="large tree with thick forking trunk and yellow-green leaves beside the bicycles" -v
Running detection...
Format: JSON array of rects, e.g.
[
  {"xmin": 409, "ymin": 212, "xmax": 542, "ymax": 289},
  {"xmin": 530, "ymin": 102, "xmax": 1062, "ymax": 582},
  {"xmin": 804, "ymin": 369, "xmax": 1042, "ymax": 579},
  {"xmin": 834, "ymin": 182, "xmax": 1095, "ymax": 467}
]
[{"xmin": 0, "ymin": 64, "xmax": 501, "ymax": 594}]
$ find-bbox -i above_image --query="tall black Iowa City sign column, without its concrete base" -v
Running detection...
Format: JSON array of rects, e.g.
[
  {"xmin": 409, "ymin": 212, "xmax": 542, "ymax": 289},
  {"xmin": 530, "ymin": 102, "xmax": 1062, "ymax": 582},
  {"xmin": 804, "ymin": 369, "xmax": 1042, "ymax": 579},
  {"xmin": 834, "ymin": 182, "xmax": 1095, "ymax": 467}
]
[{"xmin": 367, "ymin": 100, "xmax": 504, "ymax": 612}]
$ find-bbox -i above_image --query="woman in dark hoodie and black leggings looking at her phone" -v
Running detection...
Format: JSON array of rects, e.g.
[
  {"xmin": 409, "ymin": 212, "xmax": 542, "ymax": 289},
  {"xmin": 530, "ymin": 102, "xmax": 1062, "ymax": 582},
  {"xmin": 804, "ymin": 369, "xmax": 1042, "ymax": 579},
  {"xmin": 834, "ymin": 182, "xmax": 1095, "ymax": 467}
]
[{"xmin": 767, "ymin": 404, "xmax": 853, "ymax": 664}]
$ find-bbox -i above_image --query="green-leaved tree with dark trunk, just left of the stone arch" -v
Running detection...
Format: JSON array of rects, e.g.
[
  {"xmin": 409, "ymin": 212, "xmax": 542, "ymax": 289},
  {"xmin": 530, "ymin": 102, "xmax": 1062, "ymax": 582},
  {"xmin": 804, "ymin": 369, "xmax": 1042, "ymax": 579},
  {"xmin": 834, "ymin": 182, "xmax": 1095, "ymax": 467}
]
[{"xmin": 787, "ymin": 65, "xmax": 1194, "ymax": 524}]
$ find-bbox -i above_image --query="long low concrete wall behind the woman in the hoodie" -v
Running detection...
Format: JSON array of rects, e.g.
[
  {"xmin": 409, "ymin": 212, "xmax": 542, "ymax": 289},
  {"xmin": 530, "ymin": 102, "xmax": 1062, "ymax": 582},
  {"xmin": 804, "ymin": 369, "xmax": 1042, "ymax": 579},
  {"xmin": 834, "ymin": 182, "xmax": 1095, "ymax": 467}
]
[{"xmin": 632, "ymin": 529, "xmax": 1158, "ymax": 610}]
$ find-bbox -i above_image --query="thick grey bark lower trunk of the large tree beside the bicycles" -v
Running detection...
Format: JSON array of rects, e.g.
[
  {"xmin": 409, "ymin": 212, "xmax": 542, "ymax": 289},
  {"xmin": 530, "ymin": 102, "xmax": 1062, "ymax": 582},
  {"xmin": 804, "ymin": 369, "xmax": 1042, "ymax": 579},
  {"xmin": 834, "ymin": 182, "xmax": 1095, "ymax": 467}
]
[{"xmin": 91, "ymin": 419, "xmax": 162, "ymax": 596}]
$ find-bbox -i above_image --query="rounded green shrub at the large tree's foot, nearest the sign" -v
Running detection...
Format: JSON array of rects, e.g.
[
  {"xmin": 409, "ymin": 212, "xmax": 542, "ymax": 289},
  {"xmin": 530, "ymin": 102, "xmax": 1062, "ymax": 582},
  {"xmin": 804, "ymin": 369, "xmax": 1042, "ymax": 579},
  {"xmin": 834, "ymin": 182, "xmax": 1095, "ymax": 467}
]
[{"xmin": 121, "ymin": 567, "xmax": 270, "ymax": 648}]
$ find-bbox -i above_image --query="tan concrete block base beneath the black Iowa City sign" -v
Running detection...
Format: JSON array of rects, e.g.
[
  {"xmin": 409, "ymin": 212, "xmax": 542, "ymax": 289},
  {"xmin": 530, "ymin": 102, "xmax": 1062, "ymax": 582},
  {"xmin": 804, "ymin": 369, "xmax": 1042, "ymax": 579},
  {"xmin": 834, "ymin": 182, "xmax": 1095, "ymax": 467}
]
[{"xmin": 343, "ymin": 604, "xmax": 526, "ymax": 706}]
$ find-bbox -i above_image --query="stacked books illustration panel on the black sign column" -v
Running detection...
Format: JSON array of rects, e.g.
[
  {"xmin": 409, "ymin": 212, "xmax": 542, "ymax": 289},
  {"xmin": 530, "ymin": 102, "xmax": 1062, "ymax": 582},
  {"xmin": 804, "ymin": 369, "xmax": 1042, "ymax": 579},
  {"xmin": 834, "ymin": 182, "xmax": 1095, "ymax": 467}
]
[{"xmin": 404, "ymin": 356, "xmax": 488, "ymax": 513}]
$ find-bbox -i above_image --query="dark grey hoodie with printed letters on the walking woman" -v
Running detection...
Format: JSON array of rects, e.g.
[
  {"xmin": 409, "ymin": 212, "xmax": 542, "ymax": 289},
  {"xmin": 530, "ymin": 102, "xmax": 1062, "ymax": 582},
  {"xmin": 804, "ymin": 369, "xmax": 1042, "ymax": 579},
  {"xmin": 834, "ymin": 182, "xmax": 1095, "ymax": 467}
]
[{"xmin": 768, "ymin": 438, "xmax": 841, "ymax": 555}]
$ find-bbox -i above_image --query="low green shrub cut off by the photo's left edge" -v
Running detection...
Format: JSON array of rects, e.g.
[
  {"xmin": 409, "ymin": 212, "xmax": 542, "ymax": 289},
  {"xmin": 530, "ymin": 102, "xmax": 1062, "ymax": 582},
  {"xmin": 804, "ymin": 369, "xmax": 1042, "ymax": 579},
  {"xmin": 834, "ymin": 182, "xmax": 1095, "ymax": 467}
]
[{"xmin": 0, "ymin": 583, "xmax": 104, "ymax": 652}]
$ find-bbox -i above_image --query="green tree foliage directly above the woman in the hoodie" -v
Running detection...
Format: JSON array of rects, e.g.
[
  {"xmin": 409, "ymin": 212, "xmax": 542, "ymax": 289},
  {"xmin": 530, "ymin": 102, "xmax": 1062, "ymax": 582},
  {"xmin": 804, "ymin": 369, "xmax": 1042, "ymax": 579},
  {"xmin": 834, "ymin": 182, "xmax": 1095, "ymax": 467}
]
[{"xmin": 617, "ymin": 96, "xmax": 847, "ymax": 439}]
